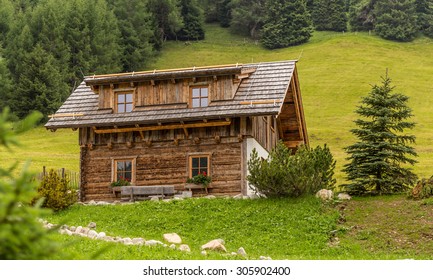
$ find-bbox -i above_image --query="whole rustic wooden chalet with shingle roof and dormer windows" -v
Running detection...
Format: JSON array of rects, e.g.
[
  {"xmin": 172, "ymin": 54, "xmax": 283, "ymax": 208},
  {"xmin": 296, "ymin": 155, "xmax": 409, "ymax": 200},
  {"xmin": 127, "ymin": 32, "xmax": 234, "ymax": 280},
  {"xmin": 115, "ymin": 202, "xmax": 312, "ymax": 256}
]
[{"xmin": 45, "ymin": 61, "xmax": 308, "ymax": 200}]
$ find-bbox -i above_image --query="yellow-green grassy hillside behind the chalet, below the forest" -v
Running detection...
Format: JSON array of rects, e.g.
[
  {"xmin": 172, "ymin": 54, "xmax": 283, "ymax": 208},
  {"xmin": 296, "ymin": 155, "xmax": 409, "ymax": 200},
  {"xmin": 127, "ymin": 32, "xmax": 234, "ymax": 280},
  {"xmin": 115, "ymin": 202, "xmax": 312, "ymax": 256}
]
[{"xmin": 0, "ymin": 25, "xmax": 433, "ymax": 183}]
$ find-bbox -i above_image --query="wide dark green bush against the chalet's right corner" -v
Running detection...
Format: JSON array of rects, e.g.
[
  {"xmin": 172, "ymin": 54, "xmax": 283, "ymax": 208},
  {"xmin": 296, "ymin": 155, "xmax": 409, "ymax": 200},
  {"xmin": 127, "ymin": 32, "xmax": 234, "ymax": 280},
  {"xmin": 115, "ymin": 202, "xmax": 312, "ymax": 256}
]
[{"xmin": 247, "ymin": 142, "xmax": 335, "ymax": 197}]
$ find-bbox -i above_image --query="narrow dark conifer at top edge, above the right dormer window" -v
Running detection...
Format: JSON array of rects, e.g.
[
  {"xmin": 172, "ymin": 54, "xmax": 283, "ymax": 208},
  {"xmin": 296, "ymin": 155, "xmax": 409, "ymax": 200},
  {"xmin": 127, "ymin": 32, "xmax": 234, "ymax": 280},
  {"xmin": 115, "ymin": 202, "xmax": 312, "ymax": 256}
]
[{"xmin": 176, "ymin": 0, "xmax": 204, "ymax": 41}]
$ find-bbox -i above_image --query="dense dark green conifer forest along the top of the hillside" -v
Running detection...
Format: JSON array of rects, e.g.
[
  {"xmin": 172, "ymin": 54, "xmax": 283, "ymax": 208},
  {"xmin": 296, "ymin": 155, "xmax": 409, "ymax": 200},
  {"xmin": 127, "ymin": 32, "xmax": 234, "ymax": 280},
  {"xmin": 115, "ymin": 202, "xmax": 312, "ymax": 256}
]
[{"xmin": 0, "ymin": 0, "xmax": 433, "ymax": 122}]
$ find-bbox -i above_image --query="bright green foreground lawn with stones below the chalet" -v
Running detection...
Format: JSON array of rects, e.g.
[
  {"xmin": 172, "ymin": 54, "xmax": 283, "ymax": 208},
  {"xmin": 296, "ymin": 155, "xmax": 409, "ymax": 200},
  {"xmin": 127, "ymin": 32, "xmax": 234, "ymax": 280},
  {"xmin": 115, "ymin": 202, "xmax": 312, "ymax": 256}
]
[{"xmin": 44, "ymin": 196, "xmax": 433, "ymax": 260}]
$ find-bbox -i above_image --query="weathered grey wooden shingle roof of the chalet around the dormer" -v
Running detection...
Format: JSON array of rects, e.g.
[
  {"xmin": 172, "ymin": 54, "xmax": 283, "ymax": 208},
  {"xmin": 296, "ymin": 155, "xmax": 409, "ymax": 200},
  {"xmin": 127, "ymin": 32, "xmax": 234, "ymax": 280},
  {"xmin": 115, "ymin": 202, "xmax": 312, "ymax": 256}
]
[{"xmin": 45, "ymin": 61, "xmax": 296, "ymax": 129}]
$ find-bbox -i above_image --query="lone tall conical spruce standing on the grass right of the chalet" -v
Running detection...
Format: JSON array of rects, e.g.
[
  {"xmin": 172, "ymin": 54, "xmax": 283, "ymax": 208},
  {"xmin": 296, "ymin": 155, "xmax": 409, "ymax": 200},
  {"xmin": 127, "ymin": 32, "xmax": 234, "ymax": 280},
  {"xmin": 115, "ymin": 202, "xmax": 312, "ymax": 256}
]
[{"xmin": 343, "ymin": 76, "xmax": 417, "ymax": 194}]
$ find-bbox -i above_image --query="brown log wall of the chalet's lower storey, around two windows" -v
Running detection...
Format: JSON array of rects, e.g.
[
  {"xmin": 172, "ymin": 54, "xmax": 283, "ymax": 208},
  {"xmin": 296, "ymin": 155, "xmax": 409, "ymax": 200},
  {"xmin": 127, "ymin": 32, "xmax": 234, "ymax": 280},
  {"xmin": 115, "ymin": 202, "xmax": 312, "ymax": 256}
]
[{"xmin": 79, "ymin": 118, "xmax": 245, "ymax": 200}]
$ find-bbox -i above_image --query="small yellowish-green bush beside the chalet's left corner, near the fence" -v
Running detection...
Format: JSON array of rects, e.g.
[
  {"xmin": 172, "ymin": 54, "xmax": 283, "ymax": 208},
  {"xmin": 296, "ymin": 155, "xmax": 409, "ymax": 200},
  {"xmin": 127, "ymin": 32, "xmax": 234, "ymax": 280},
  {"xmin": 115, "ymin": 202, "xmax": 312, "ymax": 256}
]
[{"xmin": 38, "ymin": 169, "xmax": 78, "ymax": 211}]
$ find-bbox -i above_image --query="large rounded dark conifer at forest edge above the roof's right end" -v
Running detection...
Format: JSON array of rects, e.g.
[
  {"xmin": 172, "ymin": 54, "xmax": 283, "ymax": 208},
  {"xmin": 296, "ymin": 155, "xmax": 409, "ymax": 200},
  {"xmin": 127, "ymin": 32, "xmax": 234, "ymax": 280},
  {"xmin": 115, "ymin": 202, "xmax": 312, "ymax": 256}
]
[{"xmin": 261, "ymin": 0, "xmax": 312, "ymax": 49}]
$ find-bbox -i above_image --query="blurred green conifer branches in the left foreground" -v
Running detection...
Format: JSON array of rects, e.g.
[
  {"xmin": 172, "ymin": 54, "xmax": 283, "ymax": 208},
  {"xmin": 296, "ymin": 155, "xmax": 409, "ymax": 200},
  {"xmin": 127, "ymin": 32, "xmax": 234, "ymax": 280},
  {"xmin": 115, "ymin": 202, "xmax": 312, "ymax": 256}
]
[{"xmin": 0, "ymin": 110, "xmax": 57, "ymax": 260}]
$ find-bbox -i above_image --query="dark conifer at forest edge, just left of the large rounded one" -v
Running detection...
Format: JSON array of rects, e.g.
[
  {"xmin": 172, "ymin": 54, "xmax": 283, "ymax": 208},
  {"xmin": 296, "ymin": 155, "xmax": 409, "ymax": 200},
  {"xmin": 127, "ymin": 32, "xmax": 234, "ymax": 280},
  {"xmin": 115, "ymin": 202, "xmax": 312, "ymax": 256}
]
[{"xmin": 230, "ymin": 0, "xmax": 266, "ymax": 39}]
